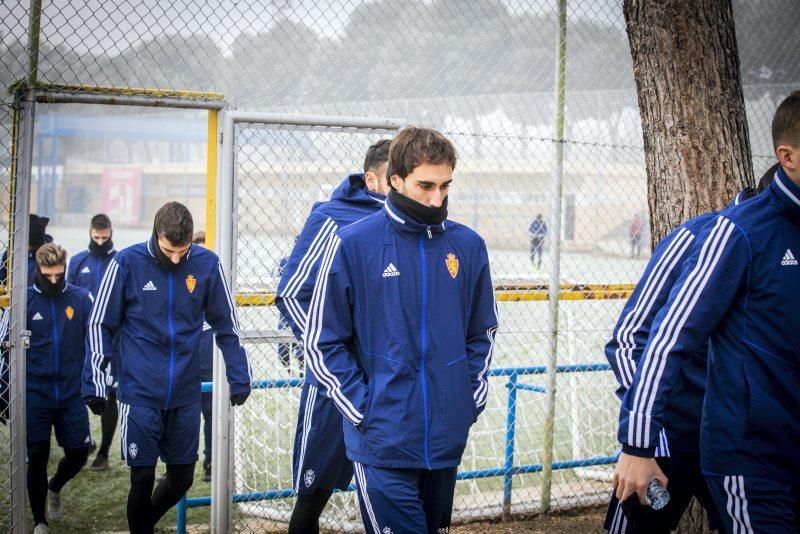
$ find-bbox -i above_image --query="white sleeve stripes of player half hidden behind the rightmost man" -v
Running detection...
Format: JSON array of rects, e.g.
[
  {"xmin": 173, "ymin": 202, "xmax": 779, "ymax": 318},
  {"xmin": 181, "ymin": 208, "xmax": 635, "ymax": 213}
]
[{"xmin": 615, "ymin": 228, "xmax": 694, "ymax": 389}]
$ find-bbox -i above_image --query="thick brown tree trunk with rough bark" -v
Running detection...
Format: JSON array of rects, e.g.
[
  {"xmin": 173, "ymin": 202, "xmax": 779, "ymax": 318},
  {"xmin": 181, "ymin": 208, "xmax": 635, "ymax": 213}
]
[{"xmin": 624, "ymin": 0, "xmax": 753, "ymax": 244}]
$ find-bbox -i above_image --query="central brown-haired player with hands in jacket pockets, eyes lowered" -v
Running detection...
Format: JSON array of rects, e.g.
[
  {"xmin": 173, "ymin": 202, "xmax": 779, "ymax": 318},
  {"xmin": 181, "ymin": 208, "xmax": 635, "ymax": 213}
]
[{"xmin": 304, "ymin": 127, "xmax": 497, "ymax": 534}]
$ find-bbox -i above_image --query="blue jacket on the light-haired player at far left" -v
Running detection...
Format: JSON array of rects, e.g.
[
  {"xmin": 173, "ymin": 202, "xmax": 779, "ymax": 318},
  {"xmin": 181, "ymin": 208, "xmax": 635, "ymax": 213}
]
[{"xmin": 0, "ymin": 284, "xmax": 92, "ymax": 408}]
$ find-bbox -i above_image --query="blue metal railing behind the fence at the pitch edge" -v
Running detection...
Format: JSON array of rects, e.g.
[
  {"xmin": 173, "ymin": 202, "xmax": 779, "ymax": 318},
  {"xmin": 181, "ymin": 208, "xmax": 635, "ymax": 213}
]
[{"xmin": 176, "ymin": 363, "xmax": 617, "ymax": 534}]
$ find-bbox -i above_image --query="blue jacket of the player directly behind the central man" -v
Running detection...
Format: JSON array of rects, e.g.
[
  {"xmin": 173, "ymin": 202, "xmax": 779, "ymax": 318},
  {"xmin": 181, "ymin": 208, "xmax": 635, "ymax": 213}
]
[{"xmin": 275, "ymin": 174, "xmax": 386, "ymax": 352}]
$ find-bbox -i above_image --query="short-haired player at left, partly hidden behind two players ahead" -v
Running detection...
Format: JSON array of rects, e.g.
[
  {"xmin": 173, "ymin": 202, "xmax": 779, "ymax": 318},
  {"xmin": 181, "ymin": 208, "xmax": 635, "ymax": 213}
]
[{"xmin": 67, "ymin": 213, "xmax": 119, "ymax": 471}]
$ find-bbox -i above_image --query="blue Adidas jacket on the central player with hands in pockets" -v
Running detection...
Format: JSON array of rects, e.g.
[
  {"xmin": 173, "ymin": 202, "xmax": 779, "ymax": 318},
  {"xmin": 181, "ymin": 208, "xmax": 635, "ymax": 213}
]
[{"xmin": 305, "ymin": 200, "xmax": 497, "ymax": 469}]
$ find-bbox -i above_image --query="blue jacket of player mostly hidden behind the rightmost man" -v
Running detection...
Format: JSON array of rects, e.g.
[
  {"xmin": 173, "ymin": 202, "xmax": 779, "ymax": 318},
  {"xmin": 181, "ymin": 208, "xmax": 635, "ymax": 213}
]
[{"xmin": 605, "ymin": 212, "xmax": 717, "ymax": 457}]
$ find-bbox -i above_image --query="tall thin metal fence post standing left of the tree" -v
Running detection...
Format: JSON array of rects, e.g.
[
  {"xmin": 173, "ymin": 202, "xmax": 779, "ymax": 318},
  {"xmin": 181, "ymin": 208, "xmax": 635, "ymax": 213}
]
[{"xmin": 541, "ymin": 0, "xmax": 567, "ymax": 513}]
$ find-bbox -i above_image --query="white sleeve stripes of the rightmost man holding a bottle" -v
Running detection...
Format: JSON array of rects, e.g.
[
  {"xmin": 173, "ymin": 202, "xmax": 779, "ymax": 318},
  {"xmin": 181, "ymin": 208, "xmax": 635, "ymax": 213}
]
[{"xmin": 628, "ymin": 217, "xmax": 734, "ymax": 448}]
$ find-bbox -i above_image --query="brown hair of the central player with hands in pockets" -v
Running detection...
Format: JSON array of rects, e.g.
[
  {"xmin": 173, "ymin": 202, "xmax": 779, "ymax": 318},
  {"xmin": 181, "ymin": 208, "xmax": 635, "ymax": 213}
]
[{"xmin": 389, "ymin": 126, "xmax": 458, "ymax": 179}]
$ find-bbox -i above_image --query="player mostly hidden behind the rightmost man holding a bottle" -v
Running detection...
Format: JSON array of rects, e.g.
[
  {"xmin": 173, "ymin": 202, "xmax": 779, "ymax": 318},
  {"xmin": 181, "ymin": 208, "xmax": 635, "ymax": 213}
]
[{"xmin": 605, "ymin": 176, "xmax": 777, "ymax": 534}]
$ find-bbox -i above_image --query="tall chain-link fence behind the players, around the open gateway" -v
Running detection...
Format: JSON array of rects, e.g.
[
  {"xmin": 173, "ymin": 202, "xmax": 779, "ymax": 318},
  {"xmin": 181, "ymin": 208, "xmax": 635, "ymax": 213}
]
[{"xmin": 0, "ymin": 0, "xmax": 800, "ymax": 530}]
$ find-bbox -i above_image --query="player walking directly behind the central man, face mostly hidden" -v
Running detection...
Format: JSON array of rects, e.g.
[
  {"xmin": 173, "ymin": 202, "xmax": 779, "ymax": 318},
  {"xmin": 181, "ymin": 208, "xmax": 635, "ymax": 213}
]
[{"xmin": 275, "ymin": 139, "xmax": 390, "ymax": 534}]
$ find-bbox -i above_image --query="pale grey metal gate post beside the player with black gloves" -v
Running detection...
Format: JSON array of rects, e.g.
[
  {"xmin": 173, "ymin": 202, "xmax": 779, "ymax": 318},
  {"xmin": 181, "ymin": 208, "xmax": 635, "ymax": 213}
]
[{"xmin": 211, "ymin": 112, "xmax": 236, "ymax": 534}]
